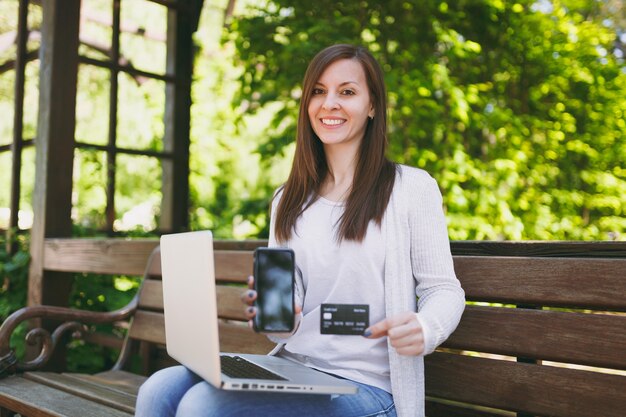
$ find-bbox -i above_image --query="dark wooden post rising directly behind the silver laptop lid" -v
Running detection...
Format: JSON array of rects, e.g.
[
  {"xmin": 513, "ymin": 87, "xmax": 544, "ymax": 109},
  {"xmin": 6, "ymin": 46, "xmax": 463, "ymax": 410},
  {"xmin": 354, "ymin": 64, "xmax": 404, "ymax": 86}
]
[{"xmin": 159, "ymin": 7, "xmax": 197, "ymax": 232}]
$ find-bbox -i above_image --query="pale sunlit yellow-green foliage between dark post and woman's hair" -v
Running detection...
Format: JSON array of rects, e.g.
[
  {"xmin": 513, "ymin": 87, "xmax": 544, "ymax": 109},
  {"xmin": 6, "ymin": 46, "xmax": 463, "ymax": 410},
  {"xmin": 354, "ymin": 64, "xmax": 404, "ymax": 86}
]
[{"xmin": 190, "ymin": 1, "xmax": 289, "ymax": 239}]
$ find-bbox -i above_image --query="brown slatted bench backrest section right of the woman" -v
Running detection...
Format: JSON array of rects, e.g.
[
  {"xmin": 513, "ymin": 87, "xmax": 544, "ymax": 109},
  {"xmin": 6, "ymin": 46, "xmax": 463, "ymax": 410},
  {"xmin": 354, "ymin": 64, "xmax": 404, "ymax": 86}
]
[{"xmin": 426, "ymin": 256, "xmax": 626, "ymax": 417}]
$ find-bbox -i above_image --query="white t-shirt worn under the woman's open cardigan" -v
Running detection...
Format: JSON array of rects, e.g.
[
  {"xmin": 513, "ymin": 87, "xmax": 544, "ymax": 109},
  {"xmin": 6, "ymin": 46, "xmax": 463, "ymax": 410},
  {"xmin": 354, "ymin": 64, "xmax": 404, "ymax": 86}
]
[{"xmin": 274, "ymin": 198, "xmax": 391, "ymax": 392}]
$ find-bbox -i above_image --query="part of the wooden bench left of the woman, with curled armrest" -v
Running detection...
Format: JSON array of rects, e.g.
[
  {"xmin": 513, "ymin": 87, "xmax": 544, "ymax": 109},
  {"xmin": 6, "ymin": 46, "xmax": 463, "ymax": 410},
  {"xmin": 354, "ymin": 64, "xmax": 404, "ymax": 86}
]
[{"xmin": 0, "ymin": 239, "xmax": 273, "ymax": 417}]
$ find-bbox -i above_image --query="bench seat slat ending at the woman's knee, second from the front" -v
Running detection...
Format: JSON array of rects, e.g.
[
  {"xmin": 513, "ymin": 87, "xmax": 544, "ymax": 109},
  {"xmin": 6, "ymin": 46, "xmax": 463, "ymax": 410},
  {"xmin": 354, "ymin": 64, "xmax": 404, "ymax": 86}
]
[{"xmin": 24, "ymin": 372, "xmax": 137, "ymax": 413}]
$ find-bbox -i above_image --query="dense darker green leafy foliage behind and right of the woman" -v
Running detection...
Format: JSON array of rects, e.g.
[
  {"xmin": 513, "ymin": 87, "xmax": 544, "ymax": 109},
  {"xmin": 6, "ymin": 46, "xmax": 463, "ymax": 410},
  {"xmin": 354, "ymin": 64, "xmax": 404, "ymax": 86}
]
[{"xmin": 226, "ymin": 0, "xmax": 626, "ymax": 240}]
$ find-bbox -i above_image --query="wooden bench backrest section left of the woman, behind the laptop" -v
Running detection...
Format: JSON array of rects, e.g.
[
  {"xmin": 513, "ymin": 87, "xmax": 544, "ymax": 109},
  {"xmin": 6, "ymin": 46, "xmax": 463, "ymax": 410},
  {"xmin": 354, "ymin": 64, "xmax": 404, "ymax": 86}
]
[{"xmin": 44, "ymin": 239, "xmax": 274, "ymax": 375}]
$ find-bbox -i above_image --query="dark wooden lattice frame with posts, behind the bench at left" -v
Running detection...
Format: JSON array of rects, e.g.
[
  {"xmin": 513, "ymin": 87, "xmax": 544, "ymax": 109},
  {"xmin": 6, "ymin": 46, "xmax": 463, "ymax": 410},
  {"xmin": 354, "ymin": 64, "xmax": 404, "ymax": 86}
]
[{"xmin": 0, "ymin": 0, "xmax": 203, "ymax": 322}]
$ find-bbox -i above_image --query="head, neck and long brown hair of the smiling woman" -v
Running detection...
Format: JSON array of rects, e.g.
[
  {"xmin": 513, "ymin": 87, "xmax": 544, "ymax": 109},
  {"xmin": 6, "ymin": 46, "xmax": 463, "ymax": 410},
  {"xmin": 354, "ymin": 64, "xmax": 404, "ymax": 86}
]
[{"xmin": 276, "ymin": 45, "xmax": 396, "ymax": 240}]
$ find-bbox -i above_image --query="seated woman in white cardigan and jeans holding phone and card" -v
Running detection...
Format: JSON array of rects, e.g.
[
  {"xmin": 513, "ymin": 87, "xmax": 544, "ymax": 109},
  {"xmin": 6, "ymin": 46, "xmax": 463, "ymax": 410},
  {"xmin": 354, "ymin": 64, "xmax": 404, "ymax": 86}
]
[{"xmin": 137, "ymin": 45, "xmax": 465, "ymax": 417}]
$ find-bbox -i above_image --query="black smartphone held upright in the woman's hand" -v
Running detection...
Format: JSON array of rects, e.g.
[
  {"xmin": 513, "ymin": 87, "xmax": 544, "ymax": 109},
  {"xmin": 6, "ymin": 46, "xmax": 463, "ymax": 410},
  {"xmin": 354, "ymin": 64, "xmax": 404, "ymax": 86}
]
[{"xmin": 253, "ymin": 248, "xmax": 296, "ymax": 333}]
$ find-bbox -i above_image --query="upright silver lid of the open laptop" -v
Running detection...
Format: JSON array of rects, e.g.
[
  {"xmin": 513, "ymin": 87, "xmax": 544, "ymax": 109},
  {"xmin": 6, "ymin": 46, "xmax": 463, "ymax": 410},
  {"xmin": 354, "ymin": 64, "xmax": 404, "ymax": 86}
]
[{"xmin": 161, "ymin": 231, "xmax": 221, "ymax": 387}]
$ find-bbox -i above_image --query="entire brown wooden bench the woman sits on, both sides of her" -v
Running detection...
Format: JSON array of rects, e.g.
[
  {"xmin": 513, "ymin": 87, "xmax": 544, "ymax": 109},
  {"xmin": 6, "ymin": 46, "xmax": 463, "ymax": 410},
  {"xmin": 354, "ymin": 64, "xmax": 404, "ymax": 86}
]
[{"xmin": 0, "ymin": 239, "xmax": 626, "ymax": 417}]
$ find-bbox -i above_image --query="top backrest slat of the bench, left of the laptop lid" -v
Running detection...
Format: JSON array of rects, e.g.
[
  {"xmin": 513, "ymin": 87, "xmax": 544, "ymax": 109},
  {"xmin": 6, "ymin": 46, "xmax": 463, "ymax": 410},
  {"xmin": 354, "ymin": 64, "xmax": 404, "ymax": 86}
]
[{"xmin": 44, "ymin": 239, "xmax": 159, "ymax": 275}]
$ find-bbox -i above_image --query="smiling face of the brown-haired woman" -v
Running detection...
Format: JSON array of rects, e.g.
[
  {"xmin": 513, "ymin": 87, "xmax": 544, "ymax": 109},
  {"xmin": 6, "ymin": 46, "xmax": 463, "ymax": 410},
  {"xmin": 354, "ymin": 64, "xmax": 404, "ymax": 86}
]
[{"xmin": 308, "ymin": 59, "xmax": 374, "ymax": 147}]
